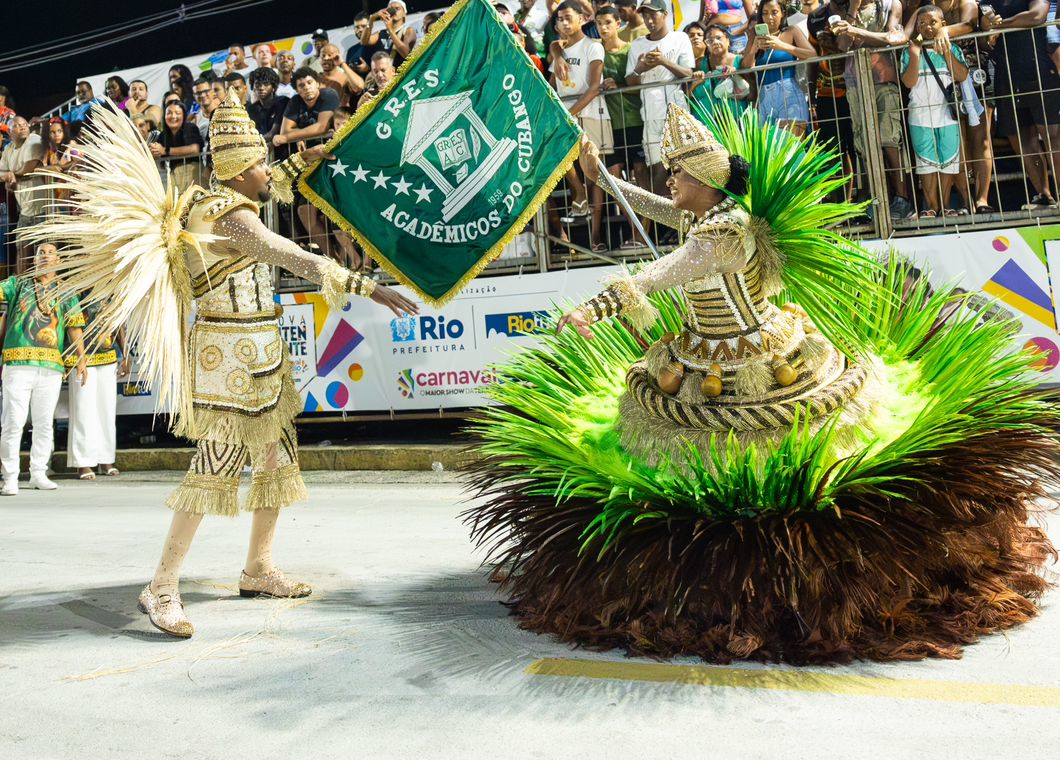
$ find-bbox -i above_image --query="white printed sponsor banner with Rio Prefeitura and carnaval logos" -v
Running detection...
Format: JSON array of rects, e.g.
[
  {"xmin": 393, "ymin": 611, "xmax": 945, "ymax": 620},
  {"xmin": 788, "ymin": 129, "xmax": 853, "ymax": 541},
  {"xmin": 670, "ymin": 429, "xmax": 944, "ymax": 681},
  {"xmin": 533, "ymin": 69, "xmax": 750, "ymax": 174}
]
[{"xmin": 47, "ymin": 226, "xmax": 1060, "ymax": 416}]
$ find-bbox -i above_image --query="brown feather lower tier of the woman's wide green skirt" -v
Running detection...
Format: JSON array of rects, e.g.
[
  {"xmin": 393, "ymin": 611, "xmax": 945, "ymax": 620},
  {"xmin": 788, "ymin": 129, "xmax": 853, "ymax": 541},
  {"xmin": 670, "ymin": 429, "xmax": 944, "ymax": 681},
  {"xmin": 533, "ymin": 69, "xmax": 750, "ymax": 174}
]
[{"xmin": 464, "ymin": 430, "xmax": 1057, "ymax": 664}]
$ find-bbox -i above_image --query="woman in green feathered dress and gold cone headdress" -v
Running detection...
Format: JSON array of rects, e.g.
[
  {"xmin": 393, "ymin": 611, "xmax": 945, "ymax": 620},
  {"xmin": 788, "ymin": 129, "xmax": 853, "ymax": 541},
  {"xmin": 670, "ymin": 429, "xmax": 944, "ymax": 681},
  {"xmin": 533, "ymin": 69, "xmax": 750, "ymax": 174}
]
[{"xmin": 465, "ymin": 103, "xmax": 1060, "ymax": 664}]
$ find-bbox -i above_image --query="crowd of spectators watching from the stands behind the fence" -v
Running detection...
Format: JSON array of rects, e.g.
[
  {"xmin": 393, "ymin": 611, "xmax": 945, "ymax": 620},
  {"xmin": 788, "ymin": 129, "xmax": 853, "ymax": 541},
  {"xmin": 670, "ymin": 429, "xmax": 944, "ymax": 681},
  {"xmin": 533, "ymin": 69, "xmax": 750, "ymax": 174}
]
[{"xmin": 6, "ymin": 0, "xmax": 1060, "ymax": 270}]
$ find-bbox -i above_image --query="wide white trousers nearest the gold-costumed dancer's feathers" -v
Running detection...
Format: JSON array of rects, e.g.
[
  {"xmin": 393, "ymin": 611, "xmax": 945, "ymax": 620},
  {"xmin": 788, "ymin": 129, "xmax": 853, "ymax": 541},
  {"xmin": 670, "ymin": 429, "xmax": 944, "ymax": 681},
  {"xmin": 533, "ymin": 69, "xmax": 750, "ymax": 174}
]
[{"xmin": 67, "ymin": 364, "xmax": 118, "ymax": 467}]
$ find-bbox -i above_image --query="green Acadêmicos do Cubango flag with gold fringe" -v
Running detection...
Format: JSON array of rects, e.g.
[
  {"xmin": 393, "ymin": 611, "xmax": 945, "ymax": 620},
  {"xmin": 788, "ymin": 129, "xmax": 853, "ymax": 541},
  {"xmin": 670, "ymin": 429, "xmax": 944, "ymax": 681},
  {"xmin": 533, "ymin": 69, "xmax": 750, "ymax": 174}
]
[{"xmin": 299, "ymin": 0, "xmax": 580, "ymax": 305}]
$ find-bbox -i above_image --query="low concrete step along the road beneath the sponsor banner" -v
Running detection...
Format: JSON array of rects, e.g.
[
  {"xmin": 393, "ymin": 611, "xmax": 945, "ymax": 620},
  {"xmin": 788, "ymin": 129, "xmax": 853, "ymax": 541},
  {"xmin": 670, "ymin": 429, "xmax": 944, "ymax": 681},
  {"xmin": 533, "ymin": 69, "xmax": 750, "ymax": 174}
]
[{"xmin": 21, "ymin": 443, "xmax": 475, "ymax": 473}]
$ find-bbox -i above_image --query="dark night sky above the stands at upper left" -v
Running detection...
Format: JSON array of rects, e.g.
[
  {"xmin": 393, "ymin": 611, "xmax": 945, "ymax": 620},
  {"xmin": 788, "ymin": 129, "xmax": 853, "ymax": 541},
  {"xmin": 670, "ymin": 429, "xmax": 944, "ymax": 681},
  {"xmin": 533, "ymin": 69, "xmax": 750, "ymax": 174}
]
[{"xmin": 7, "ymin": 0, "xmax": 430, "ymax": 116}]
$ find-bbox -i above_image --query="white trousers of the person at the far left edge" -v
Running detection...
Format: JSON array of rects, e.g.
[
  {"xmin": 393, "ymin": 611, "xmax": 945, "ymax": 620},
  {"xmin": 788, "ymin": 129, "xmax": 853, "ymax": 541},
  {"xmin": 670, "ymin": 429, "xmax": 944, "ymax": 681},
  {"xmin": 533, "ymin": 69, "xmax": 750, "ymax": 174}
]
[{"xmin": 0, "ymin": 366, "xmax": 62, "ymax": 480}]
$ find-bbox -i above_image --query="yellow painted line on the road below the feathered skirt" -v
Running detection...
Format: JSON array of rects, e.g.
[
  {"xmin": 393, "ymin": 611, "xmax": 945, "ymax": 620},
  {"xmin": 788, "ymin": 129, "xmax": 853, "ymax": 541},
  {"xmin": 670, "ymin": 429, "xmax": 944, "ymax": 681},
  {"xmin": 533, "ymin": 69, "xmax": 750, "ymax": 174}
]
[{"xmin": 527, "ymin": 658, "xmax": 1060, "ymax": 708}]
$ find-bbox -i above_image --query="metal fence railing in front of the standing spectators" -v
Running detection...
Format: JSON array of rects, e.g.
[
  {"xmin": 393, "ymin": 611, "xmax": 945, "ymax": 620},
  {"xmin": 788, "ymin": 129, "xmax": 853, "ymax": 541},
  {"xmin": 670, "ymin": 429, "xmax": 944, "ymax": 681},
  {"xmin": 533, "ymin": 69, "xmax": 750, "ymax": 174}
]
[{"xmin": 8, "ymin": 21, "xmax": 1060, "ymax": 290}]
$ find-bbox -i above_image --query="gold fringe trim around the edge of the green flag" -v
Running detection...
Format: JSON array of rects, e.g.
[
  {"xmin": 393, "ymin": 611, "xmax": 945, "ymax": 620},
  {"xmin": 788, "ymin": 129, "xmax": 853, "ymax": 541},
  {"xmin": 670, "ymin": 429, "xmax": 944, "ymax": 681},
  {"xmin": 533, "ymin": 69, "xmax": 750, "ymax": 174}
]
[{"xmin": 298, "ymin": 0, "xmax": 581, "ymax": 306}]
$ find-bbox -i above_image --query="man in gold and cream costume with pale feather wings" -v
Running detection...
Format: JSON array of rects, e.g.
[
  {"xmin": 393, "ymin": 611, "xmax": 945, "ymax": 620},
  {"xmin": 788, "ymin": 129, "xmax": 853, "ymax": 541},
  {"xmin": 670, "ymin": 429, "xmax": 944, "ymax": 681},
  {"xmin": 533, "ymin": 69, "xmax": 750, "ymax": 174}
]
[{"xmin": 27, "ymin": 93, "xmax": 418, "ymax": 638}]
